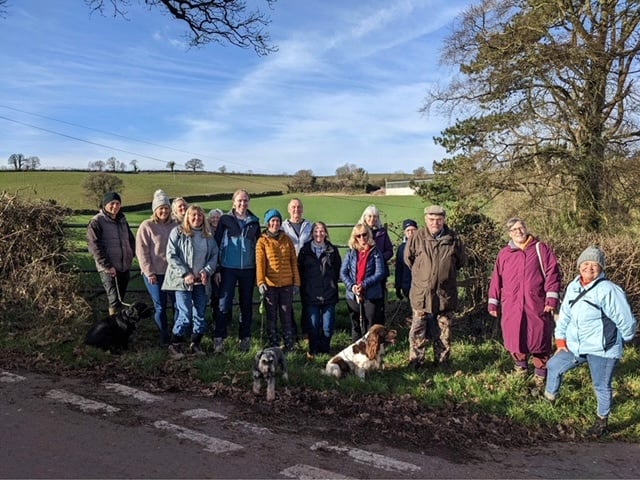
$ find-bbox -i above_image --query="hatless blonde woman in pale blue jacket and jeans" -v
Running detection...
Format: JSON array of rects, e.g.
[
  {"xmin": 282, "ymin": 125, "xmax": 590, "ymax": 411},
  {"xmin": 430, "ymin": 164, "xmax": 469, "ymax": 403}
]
[{"xmin": 162, "ymin": 205, "xmax": 218, "ymax": 358}]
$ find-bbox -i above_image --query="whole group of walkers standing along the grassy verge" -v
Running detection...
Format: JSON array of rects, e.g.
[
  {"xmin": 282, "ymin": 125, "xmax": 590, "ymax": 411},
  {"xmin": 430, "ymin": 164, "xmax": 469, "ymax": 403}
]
[{"xmin": 87, "ymin": 190, "xmax": 637, "ymax": 435}]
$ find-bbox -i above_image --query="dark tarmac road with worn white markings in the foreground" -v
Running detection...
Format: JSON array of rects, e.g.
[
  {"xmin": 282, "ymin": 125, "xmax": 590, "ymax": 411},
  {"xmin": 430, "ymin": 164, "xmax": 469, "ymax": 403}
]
[{"xmin": 0, "ymin": 367, "xmax": 640, "ymax": 479}]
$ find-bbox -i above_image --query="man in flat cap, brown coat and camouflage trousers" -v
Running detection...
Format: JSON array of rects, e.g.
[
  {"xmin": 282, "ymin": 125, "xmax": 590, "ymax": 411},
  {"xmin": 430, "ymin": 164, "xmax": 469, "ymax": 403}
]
[{"xmin": 404, "ymin": 205, "xmax": 467, "ymax": 369}]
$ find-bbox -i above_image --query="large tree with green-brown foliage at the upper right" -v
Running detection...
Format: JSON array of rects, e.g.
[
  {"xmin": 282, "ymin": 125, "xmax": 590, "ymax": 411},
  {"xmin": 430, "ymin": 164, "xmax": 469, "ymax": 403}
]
[{"xmin": 423, "ymin": 0, "xmax": 640, "ymax": 231}]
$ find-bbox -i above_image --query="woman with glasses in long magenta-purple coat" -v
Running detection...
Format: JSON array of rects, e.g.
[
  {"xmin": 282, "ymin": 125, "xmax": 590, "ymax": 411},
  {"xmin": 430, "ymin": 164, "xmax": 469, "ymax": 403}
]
[{"xmin": 489, "ymin": 217, "xmax": 561, "ymax": 387}]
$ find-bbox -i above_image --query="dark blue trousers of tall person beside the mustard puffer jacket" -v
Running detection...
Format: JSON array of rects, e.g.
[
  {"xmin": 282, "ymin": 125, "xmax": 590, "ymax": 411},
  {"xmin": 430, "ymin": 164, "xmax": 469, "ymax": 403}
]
[{"xmin": 213, "ymin": 267, "xmax": 256, "ymax": 339}]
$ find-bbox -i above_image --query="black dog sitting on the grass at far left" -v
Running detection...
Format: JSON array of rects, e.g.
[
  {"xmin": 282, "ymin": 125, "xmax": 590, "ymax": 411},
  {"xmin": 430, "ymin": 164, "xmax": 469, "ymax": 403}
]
[{"xmin": 84, "ymin": 302, "xmax": 153, "ymax": 353}]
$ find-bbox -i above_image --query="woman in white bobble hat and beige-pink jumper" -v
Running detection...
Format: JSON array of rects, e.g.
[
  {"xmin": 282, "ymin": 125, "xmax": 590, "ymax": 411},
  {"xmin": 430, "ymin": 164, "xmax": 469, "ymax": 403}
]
[{"xmin": 136, "ymin": 190, "xmax": 178, "ymax": 345}]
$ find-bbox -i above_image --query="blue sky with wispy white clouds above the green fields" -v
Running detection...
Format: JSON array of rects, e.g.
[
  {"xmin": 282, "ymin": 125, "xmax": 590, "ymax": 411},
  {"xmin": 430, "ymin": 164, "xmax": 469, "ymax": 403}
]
[{"xmin": 0, "ymin": 0, "xmax": 470, "ymax": 175}]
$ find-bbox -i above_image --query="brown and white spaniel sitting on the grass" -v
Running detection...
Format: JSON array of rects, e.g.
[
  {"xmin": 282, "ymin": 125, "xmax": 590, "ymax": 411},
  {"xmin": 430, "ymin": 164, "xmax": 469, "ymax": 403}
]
[{"xmin": 322, "ymin": 325, "xmax": 397, "ymax": 380}]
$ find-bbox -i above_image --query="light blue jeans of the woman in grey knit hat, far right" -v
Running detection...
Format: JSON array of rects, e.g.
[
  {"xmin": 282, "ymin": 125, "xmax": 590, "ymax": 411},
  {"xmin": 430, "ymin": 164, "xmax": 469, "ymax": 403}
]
[{"xmin": 546, "ymin": 350, "xmax": 618, "ymax": 418}]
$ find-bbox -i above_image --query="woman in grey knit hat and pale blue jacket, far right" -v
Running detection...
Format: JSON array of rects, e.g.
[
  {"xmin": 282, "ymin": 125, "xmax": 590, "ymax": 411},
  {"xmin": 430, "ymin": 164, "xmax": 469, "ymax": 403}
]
[{"xmin": 544, "ymin": 246, "xmax": 637, "ymax": 437}]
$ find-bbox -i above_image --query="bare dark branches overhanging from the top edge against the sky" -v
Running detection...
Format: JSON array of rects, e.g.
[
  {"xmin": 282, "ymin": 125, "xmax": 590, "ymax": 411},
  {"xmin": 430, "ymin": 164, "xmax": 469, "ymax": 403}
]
[{"xmin": 85, "ymin": 0, "xmax": 278, "ymax": 55}]
